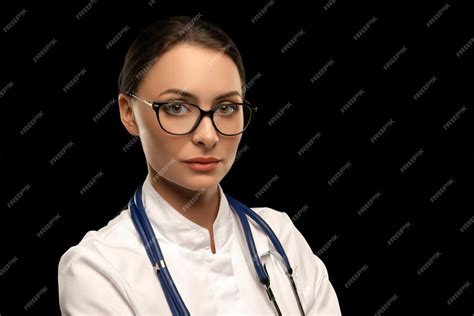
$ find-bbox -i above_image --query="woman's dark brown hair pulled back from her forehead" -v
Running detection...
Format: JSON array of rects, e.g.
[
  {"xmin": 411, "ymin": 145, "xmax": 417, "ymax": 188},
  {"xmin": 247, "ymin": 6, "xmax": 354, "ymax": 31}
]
[{"xmin": 118, "ymin": 13, "xmax": 245, "ymax": 96}]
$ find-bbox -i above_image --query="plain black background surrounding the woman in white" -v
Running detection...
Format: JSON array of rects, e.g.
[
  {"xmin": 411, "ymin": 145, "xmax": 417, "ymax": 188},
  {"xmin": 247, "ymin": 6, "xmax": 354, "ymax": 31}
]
[{"xmin": 0, "ymin": 0, "xmax": 474, "ymax": 316}]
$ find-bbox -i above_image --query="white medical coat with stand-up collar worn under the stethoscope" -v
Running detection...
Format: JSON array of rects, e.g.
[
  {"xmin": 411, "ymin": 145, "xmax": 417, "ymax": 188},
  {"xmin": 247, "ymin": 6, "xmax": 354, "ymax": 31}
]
[{"xmin": 58, "ymin": 176, "xmax": 341, "ymax": 315}]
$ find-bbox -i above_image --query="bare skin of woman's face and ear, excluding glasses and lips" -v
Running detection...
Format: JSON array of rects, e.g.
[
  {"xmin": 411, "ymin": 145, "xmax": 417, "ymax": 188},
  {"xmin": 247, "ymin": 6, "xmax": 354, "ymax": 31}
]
[{"xmin": 119, "ymin": 44, "xmax": 242, "ymax": 190}]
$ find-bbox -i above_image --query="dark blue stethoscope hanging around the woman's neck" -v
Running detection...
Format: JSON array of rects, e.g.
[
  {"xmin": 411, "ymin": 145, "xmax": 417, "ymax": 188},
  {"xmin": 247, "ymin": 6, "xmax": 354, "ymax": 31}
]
[{"xmin": 129, "ymin": 186, "xmax": 305, "ymax": 315}]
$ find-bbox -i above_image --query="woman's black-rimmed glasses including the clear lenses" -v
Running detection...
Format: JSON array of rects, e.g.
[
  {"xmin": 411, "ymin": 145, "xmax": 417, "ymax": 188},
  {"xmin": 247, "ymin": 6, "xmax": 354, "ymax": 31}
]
[{"xmin": 126, "ymin": 93, "xmax": 257, "ymax": 136}]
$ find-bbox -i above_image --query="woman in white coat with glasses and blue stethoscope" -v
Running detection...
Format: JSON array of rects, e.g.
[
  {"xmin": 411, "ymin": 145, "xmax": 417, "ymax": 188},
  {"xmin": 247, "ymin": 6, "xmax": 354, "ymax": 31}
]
[{"xmin": 58, "ymin": 17, "xmax": 340, "ymax": 315}]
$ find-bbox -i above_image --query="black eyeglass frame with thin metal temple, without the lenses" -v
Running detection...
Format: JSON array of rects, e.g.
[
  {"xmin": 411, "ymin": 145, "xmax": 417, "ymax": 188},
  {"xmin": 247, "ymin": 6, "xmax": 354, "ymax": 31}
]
[{"xmin": 125, "ymin": 92, "xmax": 258, "ymax": 136}]
